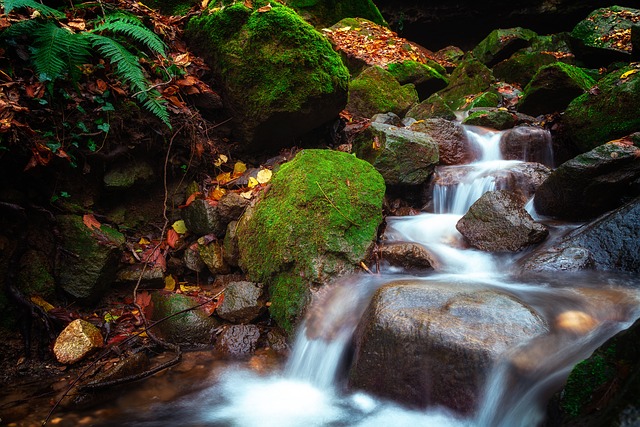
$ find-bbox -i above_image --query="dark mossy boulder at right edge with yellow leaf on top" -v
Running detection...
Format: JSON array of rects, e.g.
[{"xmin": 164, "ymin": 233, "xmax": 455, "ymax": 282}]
[{"xmin": 562, "ymin": 64, "xmax": 640, "ymax": 152}]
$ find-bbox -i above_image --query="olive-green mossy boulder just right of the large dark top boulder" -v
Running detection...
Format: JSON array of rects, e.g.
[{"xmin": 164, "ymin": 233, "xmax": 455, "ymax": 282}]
[{"xmin": 346, "ymin": 66, "xmax": 418, "ymax": 117}]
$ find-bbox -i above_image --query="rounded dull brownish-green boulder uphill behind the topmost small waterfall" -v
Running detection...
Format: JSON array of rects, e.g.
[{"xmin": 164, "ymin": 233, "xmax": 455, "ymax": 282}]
[{"xmin": 427, "ymin": 59, "xmax": 495, "ymax": 111}]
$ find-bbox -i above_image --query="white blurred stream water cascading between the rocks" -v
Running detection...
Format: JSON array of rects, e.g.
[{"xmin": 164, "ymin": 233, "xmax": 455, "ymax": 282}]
[{"xmin": 8, "ymin": 128, "xmax": 640, "ymax": 427}]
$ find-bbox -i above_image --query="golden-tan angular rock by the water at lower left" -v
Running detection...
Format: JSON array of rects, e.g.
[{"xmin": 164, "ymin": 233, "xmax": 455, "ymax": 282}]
[{"xmin": 53, "ymin": 319, "xmax": 103, "ymax": 365}]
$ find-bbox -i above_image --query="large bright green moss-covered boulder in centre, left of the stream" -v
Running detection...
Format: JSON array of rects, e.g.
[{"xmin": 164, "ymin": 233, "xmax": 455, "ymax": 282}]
[{"xmin": 238, "ymin": 150, "xmax": 385, "ymax": 332}]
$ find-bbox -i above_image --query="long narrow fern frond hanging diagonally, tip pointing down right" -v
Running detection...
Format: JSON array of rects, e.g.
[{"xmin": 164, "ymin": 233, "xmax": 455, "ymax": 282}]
[{"xmin": 86, "ymin": 33, "xmax": 171, "ymax": 127}]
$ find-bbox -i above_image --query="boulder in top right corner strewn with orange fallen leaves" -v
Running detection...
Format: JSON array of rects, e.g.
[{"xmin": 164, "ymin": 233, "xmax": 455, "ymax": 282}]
[{"xmin": 571, "ymin": 6, "xmax": 640, "ymax": 67}]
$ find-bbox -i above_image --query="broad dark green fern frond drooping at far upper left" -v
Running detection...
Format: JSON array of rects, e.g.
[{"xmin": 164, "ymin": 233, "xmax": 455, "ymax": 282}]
[{"xmin": 31, "ymin": 22, "xmax": 89, "ymax": 81}]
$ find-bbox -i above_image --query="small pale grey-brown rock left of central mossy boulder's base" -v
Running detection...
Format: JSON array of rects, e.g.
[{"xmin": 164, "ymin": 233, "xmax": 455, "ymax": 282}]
[{"xmin": 216, "ymin": 281, "xmax": 265, "ymax": 323}]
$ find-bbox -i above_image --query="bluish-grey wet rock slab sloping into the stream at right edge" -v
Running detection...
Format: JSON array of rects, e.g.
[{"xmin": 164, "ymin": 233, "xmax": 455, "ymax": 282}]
[{"xmin": 524, "ymin": 199, "xmax": 640, "ymax": 273}]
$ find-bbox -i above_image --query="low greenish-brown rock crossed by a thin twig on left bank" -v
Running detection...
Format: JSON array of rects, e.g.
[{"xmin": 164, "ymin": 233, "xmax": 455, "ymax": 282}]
[{"xmin": 147, "ymin": 291, "xmax": 220, "ymax": 345}]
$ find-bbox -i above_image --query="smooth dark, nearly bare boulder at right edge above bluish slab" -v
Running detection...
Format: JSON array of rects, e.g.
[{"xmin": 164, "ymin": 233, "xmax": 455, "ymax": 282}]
[{"xmin": 534, "ymin": 137, "xmax": 640, "ymax": 221}]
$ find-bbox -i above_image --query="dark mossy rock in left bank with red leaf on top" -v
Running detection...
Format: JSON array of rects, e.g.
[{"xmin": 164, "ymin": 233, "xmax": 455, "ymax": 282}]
[{"xmin": 56, "ymin": 215, "xmax": 125, "ymax": 303}]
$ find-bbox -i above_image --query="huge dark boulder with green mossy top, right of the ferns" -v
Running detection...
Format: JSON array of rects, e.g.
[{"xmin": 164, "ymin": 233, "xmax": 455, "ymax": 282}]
[{"xmin": 185, "ymin": 1, "xmax": 349, "ymax": 150}]
